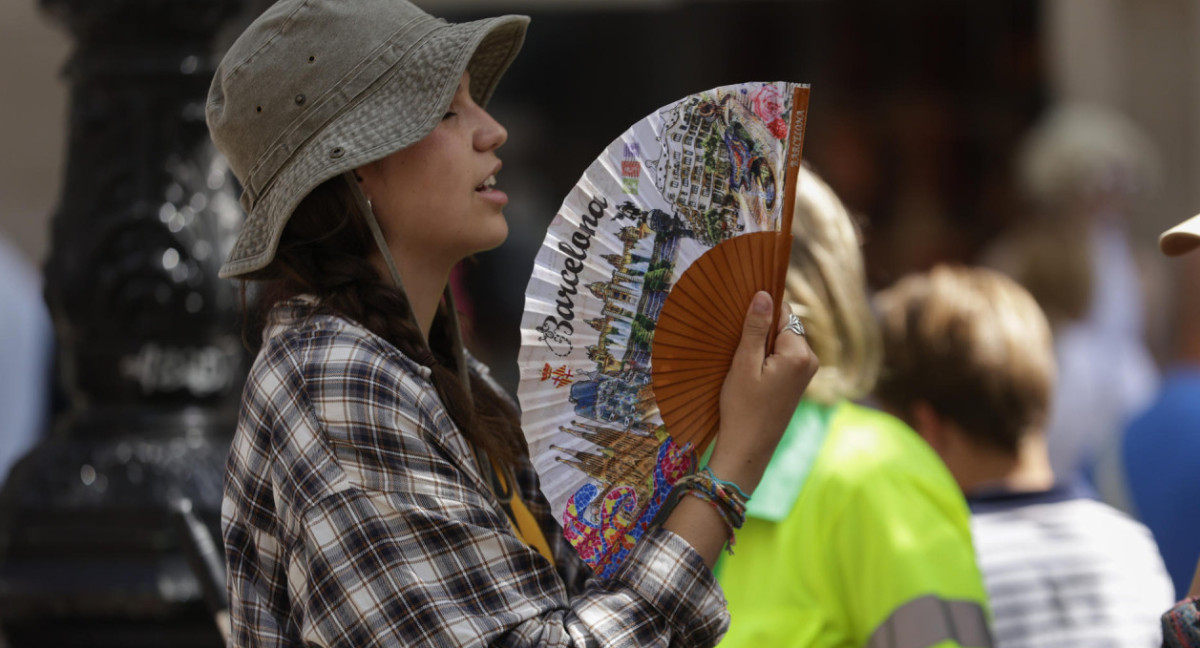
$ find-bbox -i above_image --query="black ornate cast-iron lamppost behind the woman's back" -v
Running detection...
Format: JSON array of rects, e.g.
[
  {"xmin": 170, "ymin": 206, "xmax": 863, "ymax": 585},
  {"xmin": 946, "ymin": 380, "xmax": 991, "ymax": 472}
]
[{"xmin": 0, "ymin": 0, "xmax": 246, "ymax": 648}]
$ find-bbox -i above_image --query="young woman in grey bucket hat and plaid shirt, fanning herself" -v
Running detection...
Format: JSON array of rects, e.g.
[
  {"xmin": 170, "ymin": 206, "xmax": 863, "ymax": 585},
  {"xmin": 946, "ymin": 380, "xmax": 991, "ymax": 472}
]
[{"xmin": 208, "ymin": 0, "xmax": 816, "ymax": 646}]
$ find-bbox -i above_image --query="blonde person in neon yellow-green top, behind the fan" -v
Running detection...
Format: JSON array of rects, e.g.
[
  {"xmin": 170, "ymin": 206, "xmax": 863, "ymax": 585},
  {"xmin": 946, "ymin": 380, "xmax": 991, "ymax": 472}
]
[{"xmin": 718, "ymin": 168, "xmax": 991, "ymax": 648}]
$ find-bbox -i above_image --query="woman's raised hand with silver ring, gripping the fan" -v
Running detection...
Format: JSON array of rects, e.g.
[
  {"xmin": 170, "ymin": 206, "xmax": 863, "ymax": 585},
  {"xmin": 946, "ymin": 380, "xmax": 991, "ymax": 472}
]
[{"xmin": 709, "ymin": 292, "xmax": 817, "ymax": 493}]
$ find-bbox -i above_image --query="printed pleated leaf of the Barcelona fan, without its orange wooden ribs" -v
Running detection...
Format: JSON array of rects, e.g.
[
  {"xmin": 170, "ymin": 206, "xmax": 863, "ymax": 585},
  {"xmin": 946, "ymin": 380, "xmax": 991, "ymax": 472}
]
[{"xmin": 518, "ymin": 83, "xmax": 808, "ymax": 577}]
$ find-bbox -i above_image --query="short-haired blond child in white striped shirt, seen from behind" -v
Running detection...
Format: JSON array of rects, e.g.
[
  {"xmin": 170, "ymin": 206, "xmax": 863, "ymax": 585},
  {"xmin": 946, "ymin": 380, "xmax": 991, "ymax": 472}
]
[{"xmin": 876, "ymin": 266, "xmax": 1172, "ymax": 648}]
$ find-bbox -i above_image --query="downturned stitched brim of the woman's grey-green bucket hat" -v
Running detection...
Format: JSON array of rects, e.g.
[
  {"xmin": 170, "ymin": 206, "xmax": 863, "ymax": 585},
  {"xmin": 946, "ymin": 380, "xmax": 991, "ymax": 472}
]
[{"xmin": 220, "ymin": 16, "xmax": 529, "ymax": 278}]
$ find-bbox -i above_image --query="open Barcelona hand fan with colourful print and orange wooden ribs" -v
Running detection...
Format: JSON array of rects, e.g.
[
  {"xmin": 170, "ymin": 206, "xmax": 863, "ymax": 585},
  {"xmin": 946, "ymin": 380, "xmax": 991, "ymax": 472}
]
[{"xmin": 517, "ymin": 83, "xmax": 809, "ymax": 577}]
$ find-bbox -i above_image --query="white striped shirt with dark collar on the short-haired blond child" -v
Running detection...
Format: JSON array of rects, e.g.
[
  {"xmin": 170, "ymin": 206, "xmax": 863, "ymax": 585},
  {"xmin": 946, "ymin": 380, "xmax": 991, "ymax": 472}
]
[{"xmin": 968, "ymin": 487, "xmax": 1174, "ymax": 648}]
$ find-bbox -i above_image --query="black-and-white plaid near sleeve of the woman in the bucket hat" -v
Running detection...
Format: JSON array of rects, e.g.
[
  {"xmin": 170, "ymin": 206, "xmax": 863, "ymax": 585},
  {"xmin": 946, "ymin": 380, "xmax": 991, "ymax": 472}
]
[{"xmin": 276, "ymin": 331, "xmax": 728, "ymax": 647}]
